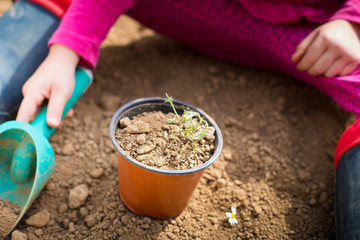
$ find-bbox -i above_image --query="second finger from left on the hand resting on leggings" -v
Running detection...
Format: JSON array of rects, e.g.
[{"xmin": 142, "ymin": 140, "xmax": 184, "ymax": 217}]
[{"xmin": 297, "ymin": 34, "xmax": 328, "ymax": 71}]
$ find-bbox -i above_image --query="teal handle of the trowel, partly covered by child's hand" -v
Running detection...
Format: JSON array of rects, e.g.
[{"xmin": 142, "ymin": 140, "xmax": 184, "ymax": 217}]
[{"xmin": 31, "ymin": 67, "xmax": 93, "ymax": 138}]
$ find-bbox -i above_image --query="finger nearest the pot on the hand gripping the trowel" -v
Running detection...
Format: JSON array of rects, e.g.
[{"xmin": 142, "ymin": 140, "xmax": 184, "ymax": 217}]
[{"xmin": 46, "ymin": 87, "xmax": 70, "ymax": 127}]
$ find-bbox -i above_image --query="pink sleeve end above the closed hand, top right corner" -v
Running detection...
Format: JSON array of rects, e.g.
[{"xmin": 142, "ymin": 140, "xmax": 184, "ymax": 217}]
[{"xmin": 329, "ymin": 0, "xmax": 360, "ymax": 24}]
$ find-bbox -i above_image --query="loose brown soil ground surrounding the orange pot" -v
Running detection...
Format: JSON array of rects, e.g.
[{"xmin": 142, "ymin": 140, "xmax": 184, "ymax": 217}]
[{"xmin": 0, "ymin": 0, "xmax": 354, "ymax": 240}]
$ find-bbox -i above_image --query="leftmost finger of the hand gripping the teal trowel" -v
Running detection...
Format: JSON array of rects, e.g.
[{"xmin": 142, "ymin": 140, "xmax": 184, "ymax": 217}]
[{"xmin": 16, "ymin": 93, "xmax": 45, "ymax": 123}]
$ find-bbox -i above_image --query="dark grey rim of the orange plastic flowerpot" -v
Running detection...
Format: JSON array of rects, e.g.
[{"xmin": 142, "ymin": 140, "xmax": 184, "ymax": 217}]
[{"xmin": 109, "ymin": 97, "xmax": 223, "ymax": 175}]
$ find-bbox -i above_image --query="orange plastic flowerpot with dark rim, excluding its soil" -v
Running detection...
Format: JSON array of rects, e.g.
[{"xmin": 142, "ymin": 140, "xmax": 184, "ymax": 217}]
[{"xmin": 110, "ymin": 98, "xmax": 223, "ymax": 219}]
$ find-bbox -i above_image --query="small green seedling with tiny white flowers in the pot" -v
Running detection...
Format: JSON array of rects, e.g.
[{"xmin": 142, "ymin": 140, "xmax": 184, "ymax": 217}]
[{"xmin": 164, "ymin": 93, "xmax": 208, "ymax": 143}]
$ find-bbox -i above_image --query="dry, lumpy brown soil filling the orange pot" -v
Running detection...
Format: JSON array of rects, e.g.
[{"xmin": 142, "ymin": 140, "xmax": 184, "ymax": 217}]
[{"xmin": 115, "ymin": 111, "xmax": 215, "ymax": 170}]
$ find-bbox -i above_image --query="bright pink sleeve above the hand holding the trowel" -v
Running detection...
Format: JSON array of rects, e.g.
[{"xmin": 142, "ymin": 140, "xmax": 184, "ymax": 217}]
[{"xmin": 48, "ymin": 0, "xmax": 135, "ymax": 69}]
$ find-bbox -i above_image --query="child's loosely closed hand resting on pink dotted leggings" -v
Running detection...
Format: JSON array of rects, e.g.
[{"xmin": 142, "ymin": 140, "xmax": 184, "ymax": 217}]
[{"xmin": 291, "ymin": 19, "xmax": 360, "ymax": 77}]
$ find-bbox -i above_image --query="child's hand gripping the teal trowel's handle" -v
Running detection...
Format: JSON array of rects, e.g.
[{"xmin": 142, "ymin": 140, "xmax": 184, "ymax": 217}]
[{"xmin": 16, "ymin": 44, "xmax": 79, "ymax": 127}]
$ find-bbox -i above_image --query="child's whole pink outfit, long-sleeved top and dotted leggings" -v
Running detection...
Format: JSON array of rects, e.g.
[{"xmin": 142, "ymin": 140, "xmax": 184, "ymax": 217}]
[{"xmin": 49, "ymin": 0, "xmax": 360, "ymax": 117}]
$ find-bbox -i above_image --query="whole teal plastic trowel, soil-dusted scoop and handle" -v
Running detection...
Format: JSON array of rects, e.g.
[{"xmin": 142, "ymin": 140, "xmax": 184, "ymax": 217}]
[{"xmin": 0, "ymin": 68, "xmax": 92, "ymax": 238}]
